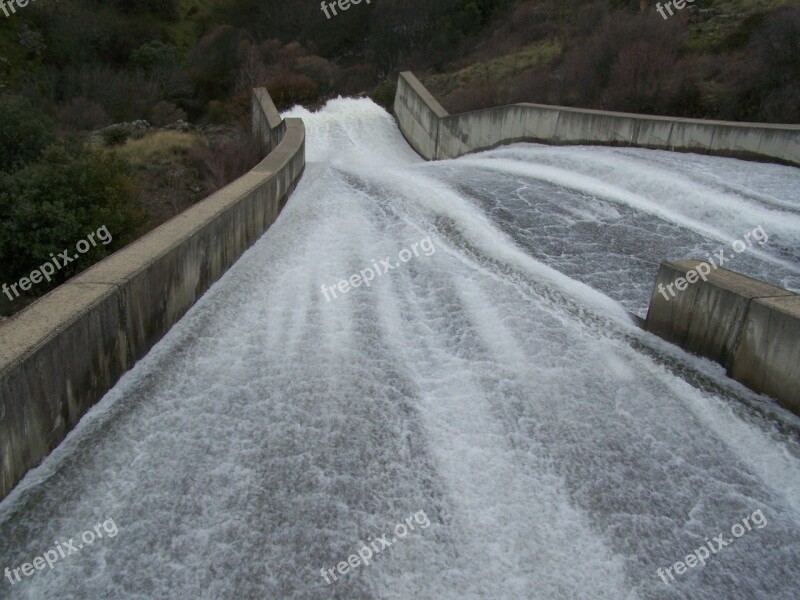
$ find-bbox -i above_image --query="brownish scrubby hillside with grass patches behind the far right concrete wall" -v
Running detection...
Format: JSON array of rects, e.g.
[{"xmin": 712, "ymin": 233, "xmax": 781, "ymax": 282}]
[{"xmin": 423, "ymin": 0, "xmax": 800, "ymax": 123}]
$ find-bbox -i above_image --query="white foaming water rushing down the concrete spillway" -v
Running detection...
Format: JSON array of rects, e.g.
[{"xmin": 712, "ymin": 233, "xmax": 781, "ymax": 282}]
[{"xmin": 0, "ymin": 100, "xmax": 800, "ymax": 600}]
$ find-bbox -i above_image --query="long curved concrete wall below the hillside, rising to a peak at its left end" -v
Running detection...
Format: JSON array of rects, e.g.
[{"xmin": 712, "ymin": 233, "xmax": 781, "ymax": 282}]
[{"xmin": 394, "ymin": 72, "xmax": 800, "ymax": 166}]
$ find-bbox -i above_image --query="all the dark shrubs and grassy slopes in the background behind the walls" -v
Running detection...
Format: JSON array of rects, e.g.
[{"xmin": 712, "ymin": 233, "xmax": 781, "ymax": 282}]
[{"xmin": 0, "ymin": 0, "xmax": 800, "ymax": 313}]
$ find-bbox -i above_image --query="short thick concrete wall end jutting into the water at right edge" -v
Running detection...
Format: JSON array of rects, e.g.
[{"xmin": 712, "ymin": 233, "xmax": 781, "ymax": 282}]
[{"xmin": 645, "ymin": 260, "xmax": 800, "ymax": 414}]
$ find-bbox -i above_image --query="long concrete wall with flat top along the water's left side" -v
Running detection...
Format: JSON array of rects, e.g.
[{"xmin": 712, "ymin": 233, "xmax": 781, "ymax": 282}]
[{"xmin": 0, "ymin": 90, "xmax": 305, "ymax": 499}]
